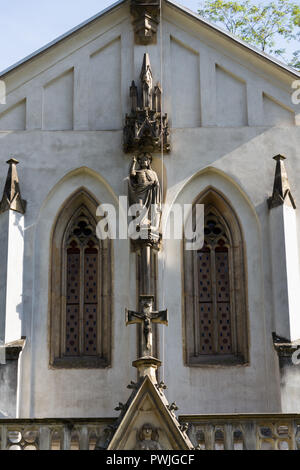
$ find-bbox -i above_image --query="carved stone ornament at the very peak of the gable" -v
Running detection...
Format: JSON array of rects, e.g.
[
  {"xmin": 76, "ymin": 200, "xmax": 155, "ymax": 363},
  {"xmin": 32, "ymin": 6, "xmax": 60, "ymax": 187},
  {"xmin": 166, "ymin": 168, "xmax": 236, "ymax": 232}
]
[{"xmin": 130, "ymin": 0, "xmax": 160, "ymax": 45}]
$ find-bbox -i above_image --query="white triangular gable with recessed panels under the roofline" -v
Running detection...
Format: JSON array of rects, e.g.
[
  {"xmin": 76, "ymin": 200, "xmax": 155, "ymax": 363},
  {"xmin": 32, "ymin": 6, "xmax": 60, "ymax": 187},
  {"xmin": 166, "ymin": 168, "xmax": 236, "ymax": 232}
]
[{"xmin": 0, "ymin": 0, "xmax": 299, "ymax": 132}]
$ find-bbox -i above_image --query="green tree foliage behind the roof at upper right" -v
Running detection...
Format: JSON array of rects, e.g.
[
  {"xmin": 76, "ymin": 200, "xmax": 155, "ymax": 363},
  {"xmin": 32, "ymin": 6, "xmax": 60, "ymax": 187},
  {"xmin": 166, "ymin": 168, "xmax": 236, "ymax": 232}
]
[{"xmin": 199, "ymin": 0, "xmax": 300, "ymax": 69}]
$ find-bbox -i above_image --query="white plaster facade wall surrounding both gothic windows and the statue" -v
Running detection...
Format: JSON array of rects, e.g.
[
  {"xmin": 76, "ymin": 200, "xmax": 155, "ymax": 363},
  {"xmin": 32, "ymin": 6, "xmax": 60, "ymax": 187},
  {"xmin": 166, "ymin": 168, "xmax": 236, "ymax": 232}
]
[{"xmin": 0, "ymin": 1, "xmax": 300, "ymax": 417}]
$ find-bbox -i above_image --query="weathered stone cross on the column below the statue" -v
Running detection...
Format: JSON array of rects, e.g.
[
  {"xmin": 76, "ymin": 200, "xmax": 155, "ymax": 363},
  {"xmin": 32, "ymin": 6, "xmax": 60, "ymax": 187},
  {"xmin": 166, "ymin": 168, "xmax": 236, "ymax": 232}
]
[{"xmin": 126, "ymin": 295, "xmax": 168, "ymax": 356}]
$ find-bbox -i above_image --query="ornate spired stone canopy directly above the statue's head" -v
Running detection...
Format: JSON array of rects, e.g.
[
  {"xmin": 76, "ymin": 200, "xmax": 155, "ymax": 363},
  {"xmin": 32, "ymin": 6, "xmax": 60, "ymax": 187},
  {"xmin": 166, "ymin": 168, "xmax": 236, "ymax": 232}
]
[{"xmin": 124, "ymin": 53, "xmax": 170, "ymax": 153}]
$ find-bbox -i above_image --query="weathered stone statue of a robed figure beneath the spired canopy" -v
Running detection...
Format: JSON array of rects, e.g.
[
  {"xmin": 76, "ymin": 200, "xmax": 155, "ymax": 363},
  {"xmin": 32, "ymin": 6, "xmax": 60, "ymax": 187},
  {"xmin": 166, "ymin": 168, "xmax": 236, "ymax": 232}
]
[{"xmin": 129, "ymin": 153, "xmax": 161, "ymax": 231}]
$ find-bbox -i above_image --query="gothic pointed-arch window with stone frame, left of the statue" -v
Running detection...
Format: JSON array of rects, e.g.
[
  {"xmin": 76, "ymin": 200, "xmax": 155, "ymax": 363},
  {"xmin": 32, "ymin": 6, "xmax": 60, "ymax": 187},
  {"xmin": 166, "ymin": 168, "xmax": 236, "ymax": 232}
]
[{"xmin": 50, "ymin": 190, "xmax": 111, "ymax": 367}]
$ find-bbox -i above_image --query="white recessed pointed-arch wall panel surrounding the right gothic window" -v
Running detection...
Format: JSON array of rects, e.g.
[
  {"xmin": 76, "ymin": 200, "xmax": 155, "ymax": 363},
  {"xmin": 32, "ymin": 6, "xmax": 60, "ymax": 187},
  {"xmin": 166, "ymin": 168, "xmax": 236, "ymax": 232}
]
[{"xmin": 165, "ymin": 170, "xmax": 274, "ymax": 413}]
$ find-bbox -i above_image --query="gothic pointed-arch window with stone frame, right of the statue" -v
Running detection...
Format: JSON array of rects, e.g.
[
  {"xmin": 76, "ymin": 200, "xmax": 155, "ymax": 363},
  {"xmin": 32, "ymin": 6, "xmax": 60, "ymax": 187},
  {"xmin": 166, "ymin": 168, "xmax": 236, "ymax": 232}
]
[{"xmin": 184, "ymin": 189, "xmax": 248, "ymax": 365}]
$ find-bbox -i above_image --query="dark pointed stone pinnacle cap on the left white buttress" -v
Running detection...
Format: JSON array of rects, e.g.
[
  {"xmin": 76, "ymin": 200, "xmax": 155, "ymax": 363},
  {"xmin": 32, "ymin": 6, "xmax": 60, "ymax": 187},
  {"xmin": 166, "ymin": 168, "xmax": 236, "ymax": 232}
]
[{"xmin": 0, "ymin": 158, "xmax": 26, "ymax": 214}]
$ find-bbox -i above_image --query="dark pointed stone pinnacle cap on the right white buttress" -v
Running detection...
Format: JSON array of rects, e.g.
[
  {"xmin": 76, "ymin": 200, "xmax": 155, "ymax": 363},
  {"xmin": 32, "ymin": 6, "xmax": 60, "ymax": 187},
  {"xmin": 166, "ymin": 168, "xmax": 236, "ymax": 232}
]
[{"xmin": 268, "ymin": 155, "xmax": 296, "ymax": 209}]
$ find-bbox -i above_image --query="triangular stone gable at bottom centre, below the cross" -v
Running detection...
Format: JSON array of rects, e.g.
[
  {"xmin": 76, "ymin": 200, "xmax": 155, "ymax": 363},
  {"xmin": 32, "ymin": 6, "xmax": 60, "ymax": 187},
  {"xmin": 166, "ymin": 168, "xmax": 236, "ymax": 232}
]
[{"xmin": 107, "ymin": 376, "xmax": 193, "ymax": 450}]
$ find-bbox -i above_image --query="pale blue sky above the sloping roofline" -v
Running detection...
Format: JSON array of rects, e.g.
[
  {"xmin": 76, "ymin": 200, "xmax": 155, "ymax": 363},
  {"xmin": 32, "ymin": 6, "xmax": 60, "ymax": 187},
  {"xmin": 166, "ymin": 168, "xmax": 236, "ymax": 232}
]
[{"xmin": 0, "ymin": 0, "xmax": 299, "ymax": 71}]
